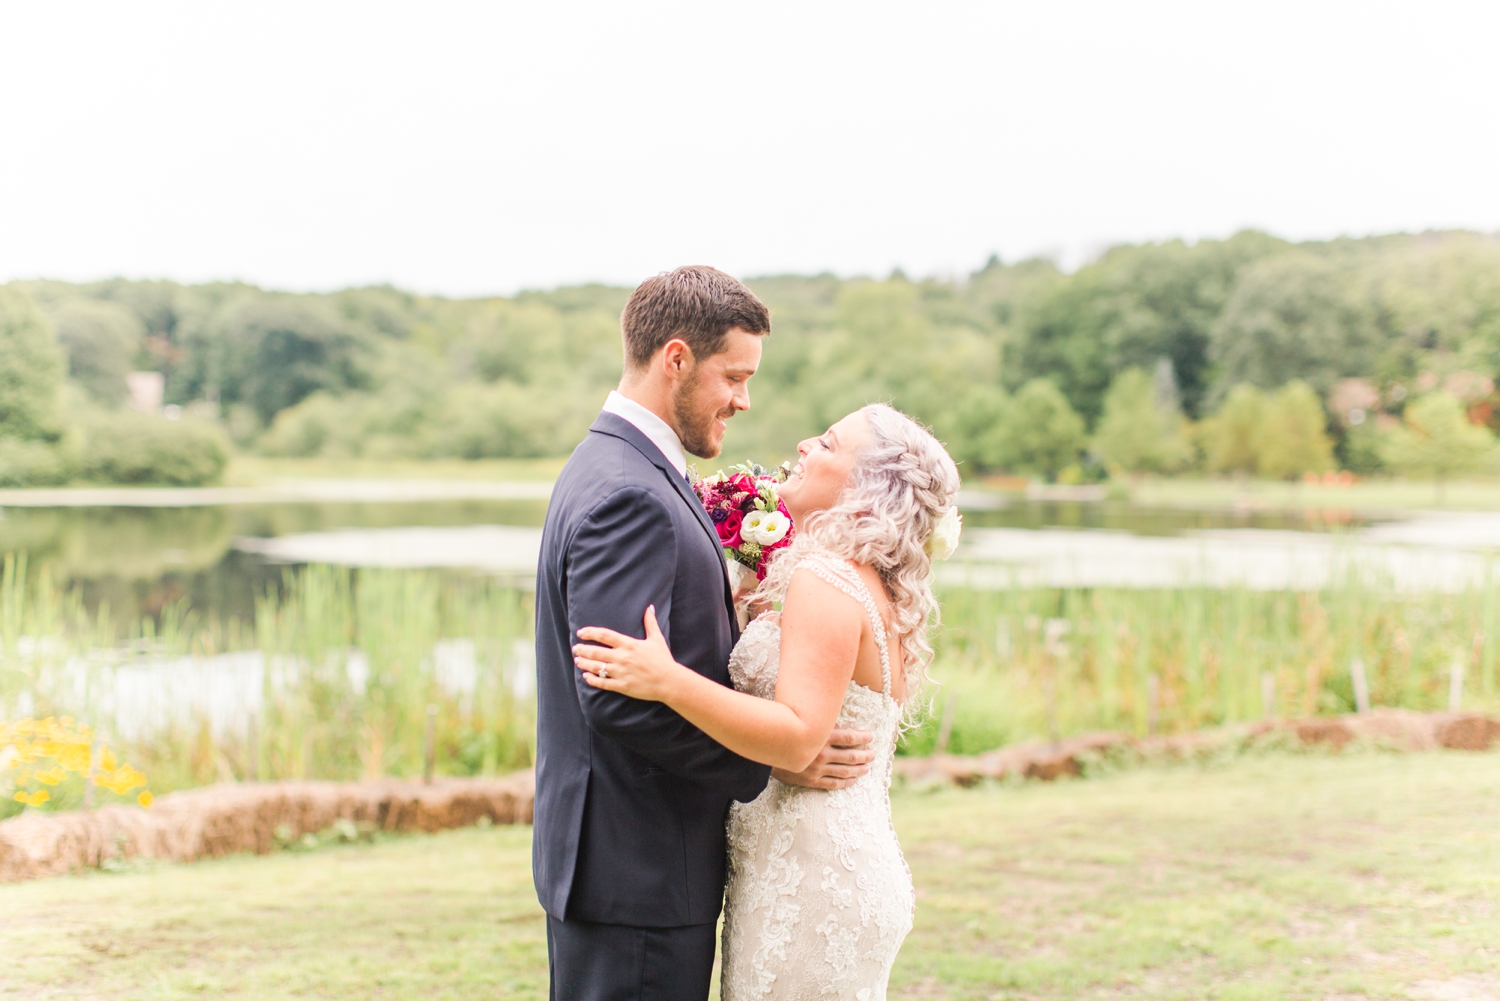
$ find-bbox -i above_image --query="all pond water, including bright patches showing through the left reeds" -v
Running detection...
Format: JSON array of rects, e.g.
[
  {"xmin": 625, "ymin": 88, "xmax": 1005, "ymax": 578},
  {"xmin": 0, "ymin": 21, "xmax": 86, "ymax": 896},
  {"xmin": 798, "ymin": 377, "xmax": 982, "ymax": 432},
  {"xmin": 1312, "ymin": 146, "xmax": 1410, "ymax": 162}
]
[{"xmin": 0, "ymin": 483, "xmax": 1500, "ymax": 750}]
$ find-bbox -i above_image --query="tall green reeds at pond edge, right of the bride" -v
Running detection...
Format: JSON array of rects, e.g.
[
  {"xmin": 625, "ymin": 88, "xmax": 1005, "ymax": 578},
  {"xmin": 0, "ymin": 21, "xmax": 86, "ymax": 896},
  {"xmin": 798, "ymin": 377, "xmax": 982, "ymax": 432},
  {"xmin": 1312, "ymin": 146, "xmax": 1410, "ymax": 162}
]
[{"xmin": 905, "ymin": 576, "xmax": 1500, "ymax": 753}]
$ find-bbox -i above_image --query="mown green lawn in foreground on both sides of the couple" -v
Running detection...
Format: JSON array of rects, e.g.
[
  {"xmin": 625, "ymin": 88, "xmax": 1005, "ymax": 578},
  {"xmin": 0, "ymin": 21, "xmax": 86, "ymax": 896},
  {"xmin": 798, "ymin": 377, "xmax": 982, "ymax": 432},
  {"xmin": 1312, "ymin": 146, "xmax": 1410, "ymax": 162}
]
[{"xmin": 0, "ymin": 752, "xmax": 1500, "ymax": 1001}]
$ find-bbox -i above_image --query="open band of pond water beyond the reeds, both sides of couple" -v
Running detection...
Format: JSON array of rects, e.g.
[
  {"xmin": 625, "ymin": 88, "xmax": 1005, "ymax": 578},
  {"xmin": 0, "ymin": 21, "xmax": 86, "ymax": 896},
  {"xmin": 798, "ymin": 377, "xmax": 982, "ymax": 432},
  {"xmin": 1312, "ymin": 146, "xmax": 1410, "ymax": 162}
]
[{"xmin": 0, "ymin": 482, "xmax": 1500, "ymax": 620}]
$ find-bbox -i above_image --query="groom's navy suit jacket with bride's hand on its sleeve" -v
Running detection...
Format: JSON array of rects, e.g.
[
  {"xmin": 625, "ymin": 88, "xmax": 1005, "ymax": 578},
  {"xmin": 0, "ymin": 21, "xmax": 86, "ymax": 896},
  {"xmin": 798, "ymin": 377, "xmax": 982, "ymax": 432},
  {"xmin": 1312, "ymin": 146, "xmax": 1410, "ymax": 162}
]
[{"xmin": 531, "ymin": 413, "xmax": 771, "ymax": 927}]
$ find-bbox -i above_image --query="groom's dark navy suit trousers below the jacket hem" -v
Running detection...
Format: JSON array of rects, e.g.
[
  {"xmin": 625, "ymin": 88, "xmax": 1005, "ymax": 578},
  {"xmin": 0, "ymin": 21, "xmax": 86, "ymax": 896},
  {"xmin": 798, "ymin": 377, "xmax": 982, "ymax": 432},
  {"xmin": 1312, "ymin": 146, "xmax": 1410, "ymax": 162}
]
[{"xmin": 548, "ymin": 914, "xmax": 719, "ymax": 1001}]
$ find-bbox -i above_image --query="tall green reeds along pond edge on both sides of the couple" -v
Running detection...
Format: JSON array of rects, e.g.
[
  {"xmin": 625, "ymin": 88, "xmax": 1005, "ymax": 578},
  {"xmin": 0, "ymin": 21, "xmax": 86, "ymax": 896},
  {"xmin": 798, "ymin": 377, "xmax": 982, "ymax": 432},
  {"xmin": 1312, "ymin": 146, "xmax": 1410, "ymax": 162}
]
[{"xmin": 0, "ymin": 560, "xmax": 1500, "ymax": 812}]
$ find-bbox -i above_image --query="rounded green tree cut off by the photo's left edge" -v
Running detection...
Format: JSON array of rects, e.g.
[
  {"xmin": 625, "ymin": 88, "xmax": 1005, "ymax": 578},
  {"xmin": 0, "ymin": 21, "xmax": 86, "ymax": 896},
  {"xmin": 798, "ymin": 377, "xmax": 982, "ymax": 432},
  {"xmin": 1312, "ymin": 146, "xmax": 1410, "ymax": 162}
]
[{"xmin": 0, "ymin": 288, "xmax": 63, "ymax": 441}]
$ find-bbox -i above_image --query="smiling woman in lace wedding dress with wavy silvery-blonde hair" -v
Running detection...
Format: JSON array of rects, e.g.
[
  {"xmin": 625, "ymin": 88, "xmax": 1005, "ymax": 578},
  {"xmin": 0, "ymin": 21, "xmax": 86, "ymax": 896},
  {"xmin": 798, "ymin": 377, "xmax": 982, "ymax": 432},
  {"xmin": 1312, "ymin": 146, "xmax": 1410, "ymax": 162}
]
[{"xmin": 573, "ymin": 404, "xmax": 959, "ymax": 1001}]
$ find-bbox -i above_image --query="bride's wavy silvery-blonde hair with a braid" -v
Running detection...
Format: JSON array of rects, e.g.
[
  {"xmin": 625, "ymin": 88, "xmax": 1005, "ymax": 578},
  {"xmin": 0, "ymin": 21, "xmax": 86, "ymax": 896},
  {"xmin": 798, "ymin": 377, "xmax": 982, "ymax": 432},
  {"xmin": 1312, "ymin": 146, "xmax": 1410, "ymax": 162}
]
[{"xmin": 759, "ymin": 404, "xmax": 959, "ymax": 722}]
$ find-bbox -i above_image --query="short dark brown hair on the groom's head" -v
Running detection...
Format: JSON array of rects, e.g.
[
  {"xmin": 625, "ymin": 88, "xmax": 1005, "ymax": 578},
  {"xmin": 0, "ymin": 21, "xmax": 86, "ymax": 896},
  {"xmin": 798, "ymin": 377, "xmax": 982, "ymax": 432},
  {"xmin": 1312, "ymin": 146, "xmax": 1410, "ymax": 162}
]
[{"xmin": 620, "ymin": 264, "xmax": 771, "ymax": 368}]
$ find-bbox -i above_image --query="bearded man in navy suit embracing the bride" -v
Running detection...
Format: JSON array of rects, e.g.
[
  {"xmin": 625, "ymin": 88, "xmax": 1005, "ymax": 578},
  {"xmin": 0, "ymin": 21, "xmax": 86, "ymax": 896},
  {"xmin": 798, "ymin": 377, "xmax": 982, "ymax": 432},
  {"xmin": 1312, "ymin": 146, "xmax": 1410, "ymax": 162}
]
[{"xmin": 533, "ymin": 267, "xmax": 873, "ymax": 1001}]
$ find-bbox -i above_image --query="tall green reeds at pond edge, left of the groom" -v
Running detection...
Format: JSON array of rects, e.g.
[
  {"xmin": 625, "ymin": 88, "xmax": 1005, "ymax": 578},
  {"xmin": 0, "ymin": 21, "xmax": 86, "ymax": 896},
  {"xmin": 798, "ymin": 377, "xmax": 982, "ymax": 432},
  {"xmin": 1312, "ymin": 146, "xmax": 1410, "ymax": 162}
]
[{"xmin": 0, "ymin": 558, "xmax": 536, "ymax": 812}]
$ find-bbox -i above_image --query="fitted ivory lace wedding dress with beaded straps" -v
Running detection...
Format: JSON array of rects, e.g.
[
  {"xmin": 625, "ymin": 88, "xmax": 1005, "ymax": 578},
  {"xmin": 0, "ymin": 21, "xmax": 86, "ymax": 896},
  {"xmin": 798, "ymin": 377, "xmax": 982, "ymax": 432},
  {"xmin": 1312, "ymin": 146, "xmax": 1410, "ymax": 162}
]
[{"xmin": 722, "ymin": 552, "xmax": 915, "ymax": 1001}]
